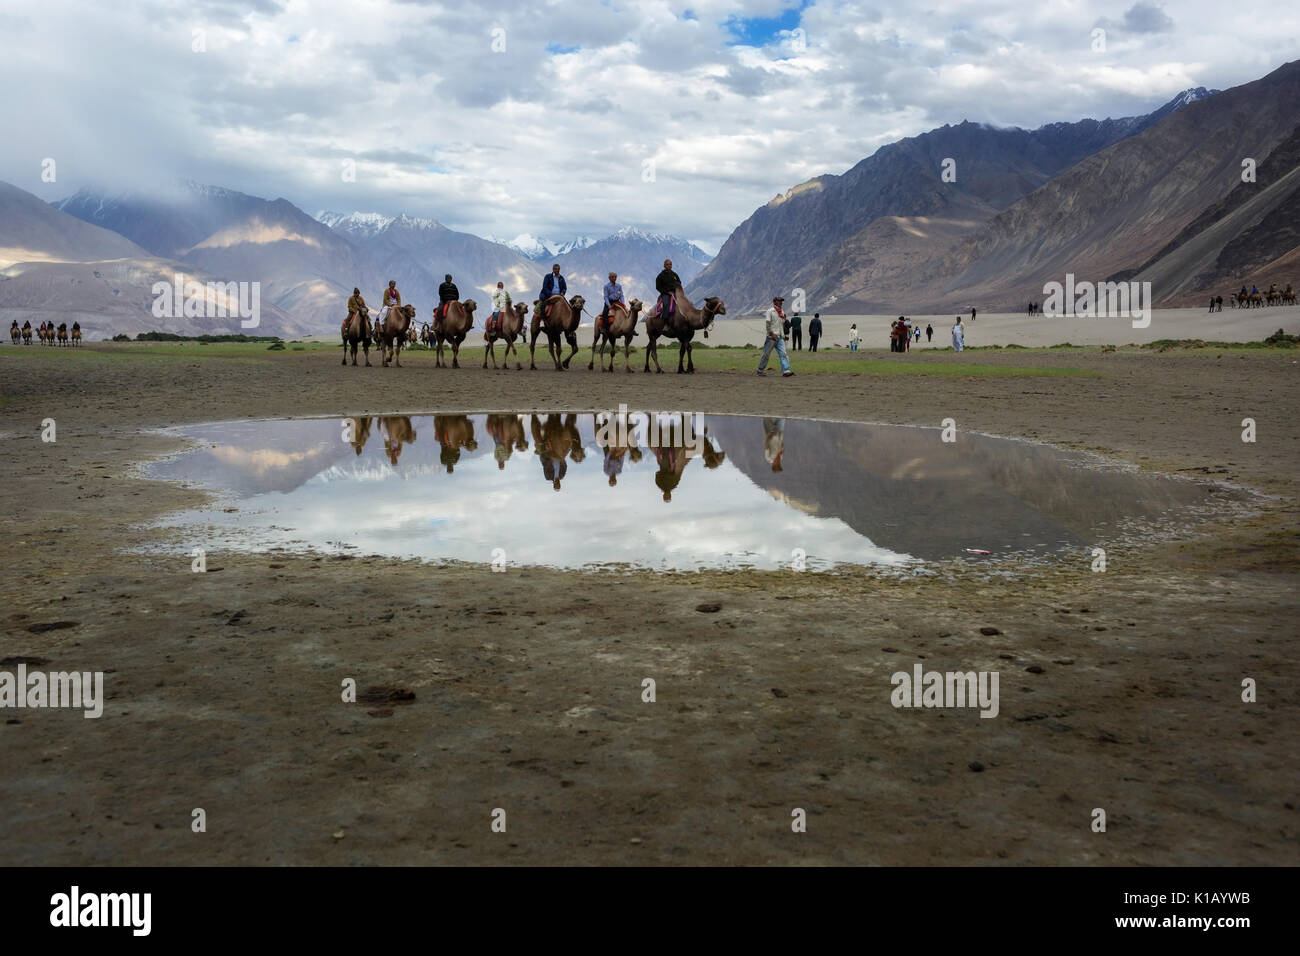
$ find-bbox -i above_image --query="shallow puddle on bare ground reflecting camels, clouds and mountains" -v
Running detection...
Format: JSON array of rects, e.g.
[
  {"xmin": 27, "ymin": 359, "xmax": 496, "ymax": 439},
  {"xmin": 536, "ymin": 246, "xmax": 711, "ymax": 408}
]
[{"xmin": 147, "ymin": 412, "xmax": 1243, "ymax": 570}]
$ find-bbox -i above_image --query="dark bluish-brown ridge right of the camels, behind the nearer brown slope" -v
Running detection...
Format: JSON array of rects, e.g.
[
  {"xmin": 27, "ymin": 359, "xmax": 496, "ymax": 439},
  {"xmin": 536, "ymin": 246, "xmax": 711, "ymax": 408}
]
[{"xmin": 689, "ymin": 88, "xmax": 1213, "ymax": 313}]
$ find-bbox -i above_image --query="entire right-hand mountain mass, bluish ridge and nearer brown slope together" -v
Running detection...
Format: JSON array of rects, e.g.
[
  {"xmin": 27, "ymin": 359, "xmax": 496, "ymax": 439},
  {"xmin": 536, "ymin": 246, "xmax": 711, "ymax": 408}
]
[{"xmin": 688, "ymin": 62, "xmax": 1300, "ymax": 315}]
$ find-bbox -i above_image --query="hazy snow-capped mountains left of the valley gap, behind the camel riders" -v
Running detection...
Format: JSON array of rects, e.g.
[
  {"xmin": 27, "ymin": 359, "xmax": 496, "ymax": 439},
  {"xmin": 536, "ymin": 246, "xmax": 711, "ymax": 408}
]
[{"xmin": 0, "ymin": 182, "xmax": 709, "ymax": 337}]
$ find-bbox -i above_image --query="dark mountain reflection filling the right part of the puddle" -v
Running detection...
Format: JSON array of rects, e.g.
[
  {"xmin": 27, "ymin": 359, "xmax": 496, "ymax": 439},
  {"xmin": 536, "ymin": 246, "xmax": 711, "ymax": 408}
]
[{"xmin": 709, "ymin": 418, "xmax": 1205, "ymax": 561}]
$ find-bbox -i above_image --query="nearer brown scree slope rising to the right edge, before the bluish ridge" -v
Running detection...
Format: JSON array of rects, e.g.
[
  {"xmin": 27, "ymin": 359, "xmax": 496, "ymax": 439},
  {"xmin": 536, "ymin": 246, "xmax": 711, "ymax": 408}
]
[{"xmin": 935, "ymin": 61, "xmax": 1300, "ymax": 311}]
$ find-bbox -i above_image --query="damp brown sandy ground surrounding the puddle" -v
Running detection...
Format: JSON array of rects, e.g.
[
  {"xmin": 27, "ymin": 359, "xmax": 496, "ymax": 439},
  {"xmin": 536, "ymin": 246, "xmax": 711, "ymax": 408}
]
[{"xmin": 0, "ymin": 345, "xmax": 1300, "ymax": 865}]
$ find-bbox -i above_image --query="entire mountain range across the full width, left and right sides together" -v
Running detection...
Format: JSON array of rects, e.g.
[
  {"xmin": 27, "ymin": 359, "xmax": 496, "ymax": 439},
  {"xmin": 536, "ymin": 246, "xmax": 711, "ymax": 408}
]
[{"xmin": 0, "ymin": 61, "xmax": 1300, "ymax": 337}]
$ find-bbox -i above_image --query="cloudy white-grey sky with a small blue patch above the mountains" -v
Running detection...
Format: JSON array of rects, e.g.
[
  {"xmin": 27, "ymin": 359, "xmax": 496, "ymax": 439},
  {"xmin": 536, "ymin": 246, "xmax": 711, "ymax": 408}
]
[{"xmin": 0, "ymin": 0, "xmax": 1300, "ymax": 252}]
